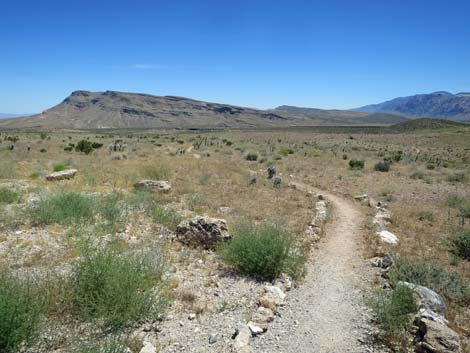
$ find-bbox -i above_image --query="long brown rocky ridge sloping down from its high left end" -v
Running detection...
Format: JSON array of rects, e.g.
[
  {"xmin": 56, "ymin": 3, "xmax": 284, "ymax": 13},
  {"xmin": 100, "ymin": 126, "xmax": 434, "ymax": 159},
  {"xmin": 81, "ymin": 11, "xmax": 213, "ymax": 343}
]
[{"xmin": 0, "ymin": 91, "xmax": 404, "ymax": 129}]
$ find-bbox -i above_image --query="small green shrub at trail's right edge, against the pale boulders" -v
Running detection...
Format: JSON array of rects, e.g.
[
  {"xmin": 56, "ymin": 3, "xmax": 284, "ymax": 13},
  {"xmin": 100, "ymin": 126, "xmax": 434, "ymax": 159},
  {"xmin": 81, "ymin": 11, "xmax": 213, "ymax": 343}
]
[{"xmin": 372, "ymin": 285, "xmax": 416, "ymax": 336}]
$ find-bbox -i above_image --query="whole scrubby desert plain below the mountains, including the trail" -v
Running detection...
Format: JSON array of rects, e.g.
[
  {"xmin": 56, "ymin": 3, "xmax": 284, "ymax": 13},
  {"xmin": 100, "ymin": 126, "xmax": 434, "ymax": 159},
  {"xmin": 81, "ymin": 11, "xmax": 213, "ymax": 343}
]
[{"xmin": 0, "ymin": 120, "xmax": 470, "ymax": 352}]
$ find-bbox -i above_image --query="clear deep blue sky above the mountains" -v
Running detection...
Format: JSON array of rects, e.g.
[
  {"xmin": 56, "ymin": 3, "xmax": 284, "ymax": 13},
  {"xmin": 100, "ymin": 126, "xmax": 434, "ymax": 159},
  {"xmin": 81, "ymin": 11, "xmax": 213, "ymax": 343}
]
[{"xmin": 0, "ymin": 0, "xmax": 470, "ymax": 113}]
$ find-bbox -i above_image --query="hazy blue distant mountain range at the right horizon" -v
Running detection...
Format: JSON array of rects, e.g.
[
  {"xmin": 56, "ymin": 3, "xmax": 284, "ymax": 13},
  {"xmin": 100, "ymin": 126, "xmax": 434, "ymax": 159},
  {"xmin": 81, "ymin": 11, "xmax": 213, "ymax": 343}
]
[{"xmin": 354, "ymin": 92, "xmax": 470, "ymax": 122}]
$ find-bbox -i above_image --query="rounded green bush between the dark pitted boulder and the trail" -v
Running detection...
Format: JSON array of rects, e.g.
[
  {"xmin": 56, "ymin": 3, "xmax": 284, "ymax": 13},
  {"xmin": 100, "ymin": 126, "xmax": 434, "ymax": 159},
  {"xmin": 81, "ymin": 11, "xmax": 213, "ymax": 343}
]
[{"xmin": 220, "ymin": 223, "xmax": 304, "ymax": 280}]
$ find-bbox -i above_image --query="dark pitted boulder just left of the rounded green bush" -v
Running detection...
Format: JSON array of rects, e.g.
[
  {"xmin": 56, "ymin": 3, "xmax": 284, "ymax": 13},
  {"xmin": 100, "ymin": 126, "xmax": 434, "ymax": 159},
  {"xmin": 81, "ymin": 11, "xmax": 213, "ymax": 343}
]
[{"xmin": 175, "ymin": 216, "xmax": 230, "ymax": 249}]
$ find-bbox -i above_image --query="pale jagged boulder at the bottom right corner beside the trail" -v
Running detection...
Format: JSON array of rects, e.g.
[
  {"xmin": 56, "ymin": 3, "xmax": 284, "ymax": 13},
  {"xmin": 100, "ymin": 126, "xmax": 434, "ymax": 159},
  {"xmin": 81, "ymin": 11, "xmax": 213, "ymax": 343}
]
[{"xmin": 415, "ymin": 317, "xmax": 462, "ymax": 353}]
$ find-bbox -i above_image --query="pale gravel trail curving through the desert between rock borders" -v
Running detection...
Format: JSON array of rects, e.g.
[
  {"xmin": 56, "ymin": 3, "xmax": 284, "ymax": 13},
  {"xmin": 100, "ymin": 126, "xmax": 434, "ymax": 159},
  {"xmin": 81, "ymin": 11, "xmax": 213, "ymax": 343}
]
[{"xmin": 253, "ymin": 188, "xmax": 381, "ymax": 353}]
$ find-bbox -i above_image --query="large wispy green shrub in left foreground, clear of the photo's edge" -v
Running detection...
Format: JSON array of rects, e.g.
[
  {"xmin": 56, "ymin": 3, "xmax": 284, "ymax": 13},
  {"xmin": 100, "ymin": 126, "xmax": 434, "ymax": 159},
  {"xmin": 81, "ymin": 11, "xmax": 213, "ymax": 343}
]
[{"xmin": 72, "ymin": 245, "xmax": 166, "ymax": 328}]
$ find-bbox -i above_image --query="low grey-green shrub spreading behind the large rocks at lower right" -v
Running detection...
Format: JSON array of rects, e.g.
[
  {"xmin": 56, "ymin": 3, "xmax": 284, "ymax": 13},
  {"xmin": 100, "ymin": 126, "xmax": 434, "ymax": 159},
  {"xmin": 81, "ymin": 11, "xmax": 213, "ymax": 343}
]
[{"xmin": 390, "ymin": 258, "xmax": 470, "ymax": 304}]
